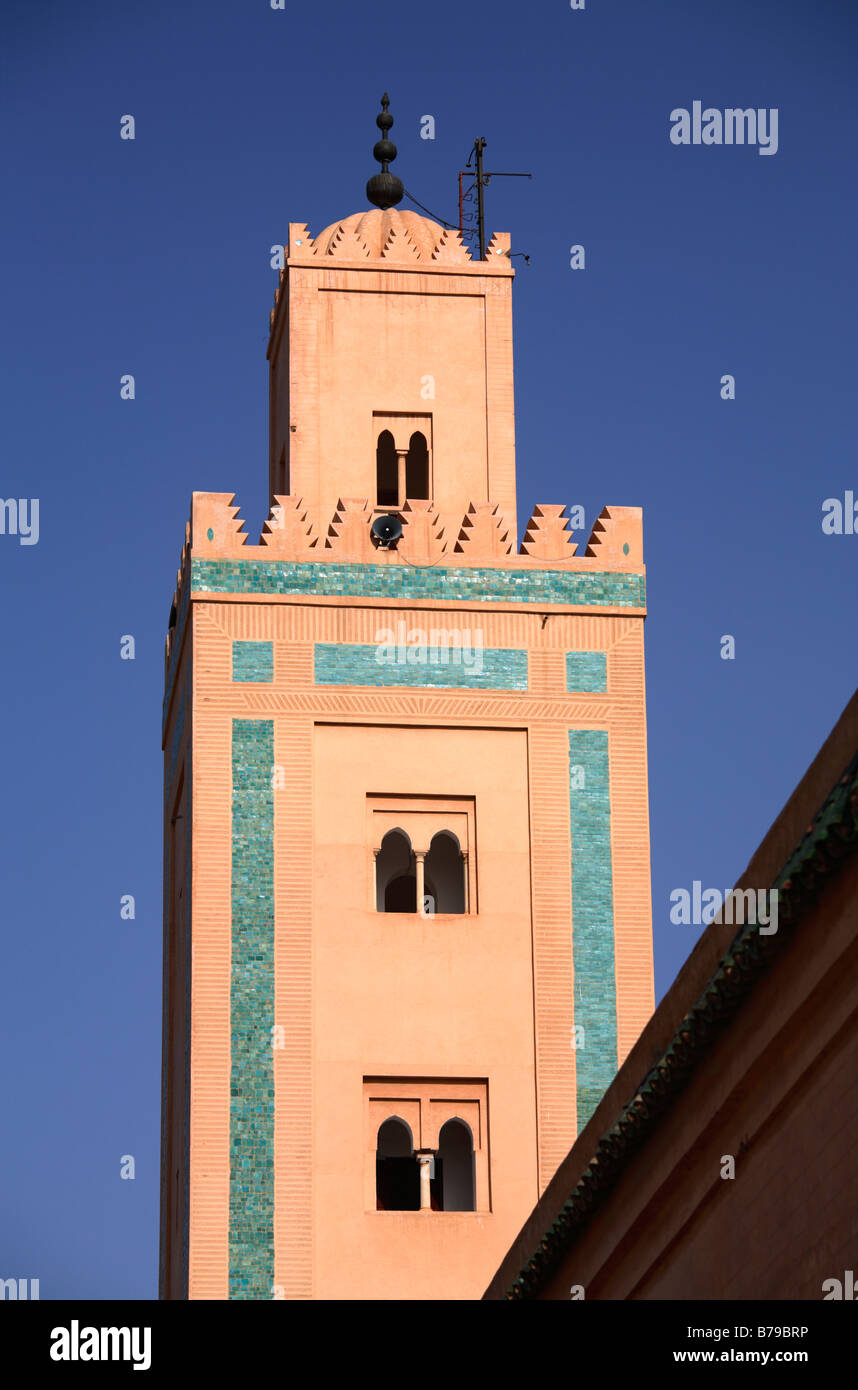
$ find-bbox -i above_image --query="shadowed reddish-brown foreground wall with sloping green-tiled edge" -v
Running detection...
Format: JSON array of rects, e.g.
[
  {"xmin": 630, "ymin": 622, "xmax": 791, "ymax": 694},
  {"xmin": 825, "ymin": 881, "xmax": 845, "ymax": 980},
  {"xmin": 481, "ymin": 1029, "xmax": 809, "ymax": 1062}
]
[{"xmin": 487, "ymin": 698, "xmax": 858, "ymax": 1300}]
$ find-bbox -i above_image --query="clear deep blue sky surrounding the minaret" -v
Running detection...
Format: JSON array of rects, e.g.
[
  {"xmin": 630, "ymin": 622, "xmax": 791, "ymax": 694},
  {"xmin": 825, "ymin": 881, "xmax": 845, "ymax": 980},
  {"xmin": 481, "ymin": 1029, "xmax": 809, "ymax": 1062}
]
[{"xmin": 0, "ymin": 0, "xmax": 858, "ymax": 1298}]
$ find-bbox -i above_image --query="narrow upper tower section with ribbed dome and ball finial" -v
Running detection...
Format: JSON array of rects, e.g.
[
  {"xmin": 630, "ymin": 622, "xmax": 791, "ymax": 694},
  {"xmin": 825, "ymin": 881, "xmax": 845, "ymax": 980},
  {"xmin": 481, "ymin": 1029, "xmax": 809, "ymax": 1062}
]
[{"xmin": 268, "ymin": 96, "xmax": 516, "ymax": 537}]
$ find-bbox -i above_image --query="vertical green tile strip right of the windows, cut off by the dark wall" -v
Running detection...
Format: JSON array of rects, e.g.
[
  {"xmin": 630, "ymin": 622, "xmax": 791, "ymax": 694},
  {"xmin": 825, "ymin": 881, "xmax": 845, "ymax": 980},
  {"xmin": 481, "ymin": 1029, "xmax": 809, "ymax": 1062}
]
[{"xmin": 569, "ymin": 728, "xmax": 617, "ymax": 1133}]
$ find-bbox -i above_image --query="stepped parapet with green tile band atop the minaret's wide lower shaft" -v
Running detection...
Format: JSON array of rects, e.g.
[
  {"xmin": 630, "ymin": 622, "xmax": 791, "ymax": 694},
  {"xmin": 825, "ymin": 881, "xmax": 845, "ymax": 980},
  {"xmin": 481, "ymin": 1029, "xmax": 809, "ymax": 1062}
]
[{"xmin": 164, "ymin": 492, "xmax": 645, "ymax": 719}]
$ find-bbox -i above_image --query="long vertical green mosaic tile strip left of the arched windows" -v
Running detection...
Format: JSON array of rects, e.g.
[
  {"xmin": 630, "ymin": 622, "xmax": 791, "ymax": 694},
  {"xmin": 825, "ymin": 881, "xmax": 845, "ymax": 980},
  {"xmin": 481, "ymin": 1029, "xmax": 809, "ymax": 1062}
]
[{"xmin": 229, "ymin": 719, "xmax": 274, "ymax": 1298}]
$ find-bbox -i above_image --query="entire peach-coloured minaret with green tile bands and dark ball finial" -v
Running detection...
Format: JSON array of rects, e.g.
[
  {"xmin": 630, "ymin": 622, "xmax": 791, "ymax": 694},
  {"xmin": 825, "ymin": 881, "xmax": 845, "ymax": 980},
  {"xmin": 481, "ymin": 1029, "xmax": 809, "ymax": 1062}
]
[{"xmin": 161, "ymin": 97, "xmax": 652, "ymax": 1298}]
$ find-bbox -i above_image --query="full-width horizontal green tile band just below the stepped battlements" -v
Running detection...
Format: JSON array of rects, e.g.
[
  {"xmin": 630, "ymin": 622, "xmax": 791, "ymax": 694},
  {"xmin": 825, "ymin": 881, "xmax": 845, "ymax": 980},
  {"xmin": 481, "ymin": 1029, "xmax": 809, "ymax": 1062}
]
[{"xmin": 191, "ymin": 560, "xmax": 647, "ymax": 607}]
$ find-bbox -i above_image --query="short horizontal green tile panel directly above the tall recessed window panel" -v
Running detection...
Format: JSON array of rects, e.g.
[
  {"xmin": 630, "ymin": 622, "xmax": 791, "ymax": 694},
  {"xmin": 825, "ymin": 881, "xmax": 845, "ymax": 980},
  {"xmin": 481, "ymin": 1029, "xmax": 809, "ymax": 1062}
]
[{"xmin": 316, "ymin": 642, "xmax": 527, "ymax": 691}]
